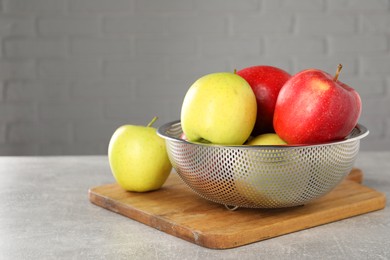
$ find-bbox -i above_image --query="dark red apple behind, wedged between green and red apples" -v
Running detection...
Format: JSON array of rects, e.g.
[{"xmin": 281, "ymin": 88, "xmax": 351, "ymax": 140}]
[{"xmin": 237, "ymin": 65, "xmax": 291, "ymax": 136}]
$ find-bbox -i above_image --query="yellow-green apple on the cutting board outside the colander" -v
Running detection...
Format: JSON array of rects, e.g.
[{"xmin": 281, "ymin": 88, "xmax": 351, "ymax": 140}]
[{"xmin": 108, "ymin": 117, "xmax": 172, "ymax": 192}]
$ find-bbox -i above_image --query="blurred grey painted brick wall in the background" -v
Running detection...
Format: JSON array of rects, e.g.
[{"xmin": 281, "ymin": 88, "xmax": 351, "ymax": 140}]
[{"xmin": 0, "ymin": 0, "xmax": 390, "ymax": 155}]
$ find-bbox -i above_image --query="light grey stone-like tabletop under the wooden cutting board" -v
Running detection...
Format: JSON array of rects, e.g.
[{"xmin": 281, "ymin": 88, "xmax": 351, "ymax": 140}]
[{"xmin": 0, "ymin": 152, "xmax": 390, "ymax": 259}]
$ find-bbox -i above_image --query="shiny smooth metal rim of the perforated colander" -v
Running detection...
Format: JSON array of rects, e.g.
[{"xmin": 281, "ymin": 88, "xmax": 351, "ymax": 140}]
[{"xmin": 157, "ymin": 120, "xmax": 369, "ymax": 149}]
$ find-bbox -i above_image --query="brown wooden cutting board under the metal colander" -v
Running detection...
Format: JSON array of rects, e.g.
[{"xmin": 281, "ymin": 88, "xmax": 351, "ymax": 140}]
[{"xmin": 89, "ymin": 169, "xmax": 386, "ymax": 249}]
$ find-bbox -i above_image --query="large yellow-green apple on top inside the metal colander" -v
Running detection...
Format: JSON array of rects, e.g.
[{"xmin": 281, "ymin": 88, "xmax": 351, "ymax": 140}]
[{"xmin": 181, "ymin": 72, "xmax": 257, "ymax": 145}]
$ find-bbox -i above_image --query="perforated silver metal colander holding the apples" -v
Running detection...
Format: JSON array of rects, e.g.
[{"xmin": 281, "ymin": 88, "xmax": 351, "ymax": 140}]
[{"xmin": 158, "ymin": 121, "xmax": 368, "ymax": 209}]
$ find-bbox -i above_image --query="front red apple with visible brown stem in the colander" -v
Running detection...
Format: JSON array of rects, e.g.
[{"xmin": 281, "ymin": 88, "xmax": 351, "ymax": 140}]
[{"xmin": 274, "ymin": 64, "xmax": 362, "ymax": 144}]
